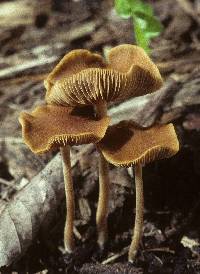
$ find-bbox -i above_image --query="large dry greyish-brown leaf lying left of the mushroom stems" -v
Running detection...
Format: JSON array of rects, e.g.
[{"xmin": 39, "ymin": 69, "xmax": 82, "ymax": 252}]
[{"xmin": 0, "ymin": 155, "xmax": 78, "ymax": 267}]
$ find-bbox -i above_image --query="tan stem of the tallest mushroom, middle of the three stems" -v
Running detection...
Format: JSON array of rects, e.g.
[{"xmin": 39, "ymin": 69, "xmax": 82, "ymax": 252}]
[{"xmin": 96, "ymin": 102, "xmax": 109, "ymax": 249}]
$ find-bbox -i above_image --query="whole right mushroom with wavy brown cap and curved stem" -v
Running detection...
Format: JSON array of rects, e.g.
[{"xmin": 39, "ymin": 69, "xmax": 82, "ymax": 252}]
[{"xmin": 97, "ymin": 121, "xmax": 179, "ymax": 262}]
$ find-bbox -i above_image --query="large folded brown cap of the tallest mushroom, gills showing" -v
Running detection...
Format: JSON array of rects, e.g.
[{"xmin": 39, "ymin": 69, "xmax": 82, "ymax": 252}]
[{"xmin": 45, "ymin": 45, "xmax": 162, "ymax": 106}]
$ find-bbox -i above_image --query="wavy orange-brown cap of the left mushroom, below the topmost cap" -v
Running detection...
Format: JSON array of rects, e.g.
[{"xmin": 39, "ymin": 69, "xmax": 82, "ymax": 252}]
[{"xmin": 19, "ymin": 105, "xmax": 110, "ymax": 153}]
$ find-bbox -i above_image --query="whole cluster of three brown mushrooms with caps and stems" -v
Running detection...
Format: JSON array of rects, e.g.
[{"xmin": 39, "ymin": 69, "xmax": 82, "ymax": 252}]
[{"xmin": 19, "ymin": 45, "xmax": 179, "ymax": 262}]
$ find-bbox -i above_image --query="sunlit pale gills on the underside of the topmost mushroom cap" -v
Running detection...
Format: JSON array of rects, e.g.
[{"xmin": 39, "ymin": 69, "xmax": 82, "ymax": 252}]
[{"xmin": 46, "ymin": 68, "xmax": 131, "ymax": 106}]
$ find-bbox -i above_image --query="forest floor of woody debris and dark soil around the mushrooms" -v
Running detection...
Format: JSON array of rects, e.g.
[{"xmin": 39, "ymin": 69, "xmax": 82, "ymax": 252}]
[{"xmin": 0, "ymin": 0, "xmax": 200, "ymax": 274}]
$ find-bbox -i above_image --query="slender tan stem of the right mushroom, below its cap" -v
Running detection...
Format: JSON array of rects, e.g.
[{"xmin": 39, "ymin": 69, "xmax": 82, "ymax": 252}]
[{"xmin": 128, "ymin": 164, "xmax": 144, "ymax": 263}]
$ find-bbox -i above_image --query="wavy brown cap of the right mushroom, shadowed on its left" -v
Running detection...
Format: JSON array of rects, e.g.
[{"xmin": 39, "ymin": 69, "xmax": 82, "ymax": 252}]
[{"xmin": 97, "ymin": 121, "xmax": 179, "ymax": 167}]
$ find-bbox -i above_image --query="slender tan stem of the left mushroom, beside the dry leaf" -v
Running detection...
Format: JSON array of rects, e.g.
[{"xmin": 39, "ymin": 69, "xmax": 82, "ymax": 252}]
[{"xmin": 60, "ymin": 146, "xmax": 75, "ymax": 253}]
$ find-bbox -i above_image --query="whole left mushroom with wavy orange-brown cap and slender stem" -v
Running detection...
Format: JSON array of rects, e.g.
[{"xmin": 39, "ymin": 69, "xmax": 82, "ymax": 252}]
[{"xmin": 19, "ymin": 105, "xmax": 110, "ymax": 253}]
